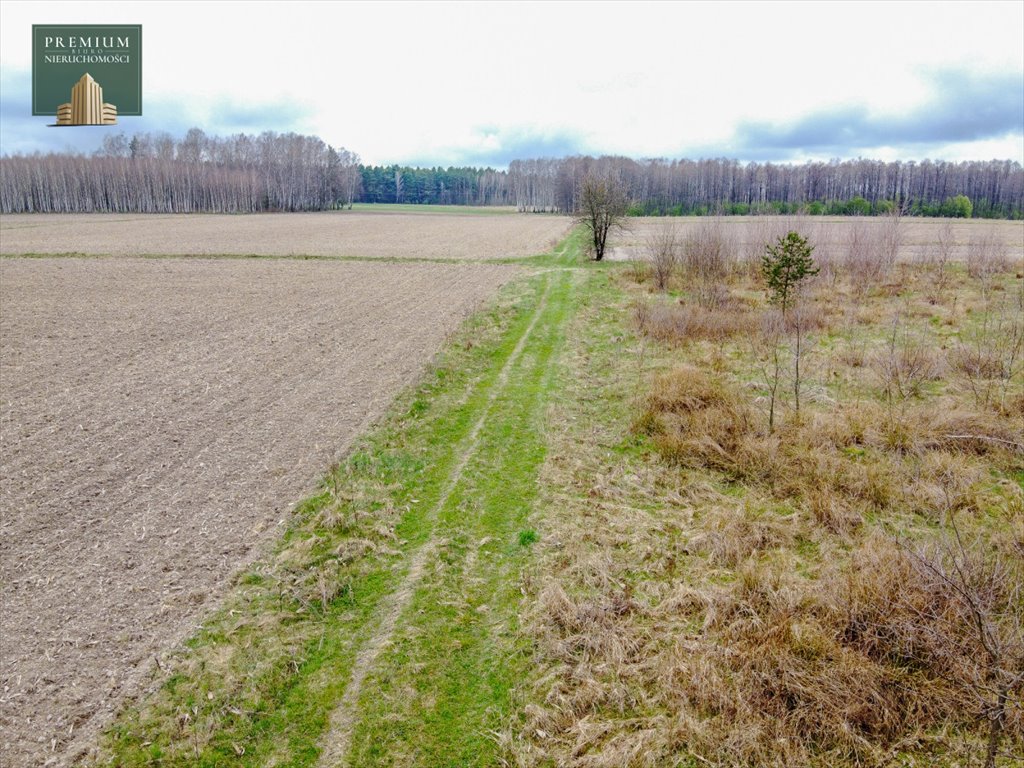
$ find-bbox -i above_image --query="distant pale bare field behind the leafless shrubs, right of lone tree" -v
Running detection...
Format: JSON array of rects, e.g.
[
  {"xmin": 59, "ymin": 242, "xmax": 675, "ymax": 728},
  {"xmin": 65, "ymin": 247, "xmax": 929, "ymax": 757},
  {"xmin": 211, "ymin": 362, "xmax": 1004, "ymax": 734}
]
[{"xmin": 608, "ymin": 216, "xmax": 1024, "ymax": 261}]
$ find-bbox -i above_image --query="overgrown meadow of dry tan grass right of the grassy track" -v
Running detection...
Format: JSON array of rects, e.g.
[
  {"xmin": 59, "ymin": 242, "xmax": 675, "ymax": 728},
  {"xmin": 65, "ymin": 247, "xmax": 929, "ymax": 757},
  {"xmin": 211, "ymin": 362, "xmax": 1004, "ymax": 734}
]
[{"xmin": 507, "ymin": 237, "xmax": 1024, "ymax": 766}]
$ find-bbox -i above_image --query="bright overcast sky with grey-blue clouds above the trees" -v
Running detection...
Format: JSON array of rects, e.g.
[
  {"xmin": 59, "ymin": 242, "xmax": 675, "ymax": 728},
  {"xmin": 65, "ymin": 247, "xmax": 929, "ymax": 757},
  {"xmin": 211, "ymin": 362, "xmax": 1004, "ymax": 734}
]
[{"xmin": 0, "ymin": 0, "xmax": 1024, "ymax": 167}]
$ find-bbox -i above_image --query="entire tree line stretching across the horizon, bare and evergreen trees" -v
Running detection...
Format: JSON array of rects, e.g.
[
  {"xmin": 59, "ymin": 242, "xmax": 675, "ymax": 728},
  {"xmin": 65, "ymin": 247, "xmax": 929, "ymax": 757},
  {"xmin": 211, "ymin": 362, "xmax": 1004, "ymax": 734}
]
[{"xmin": 0, "ymin": 128, "xmax": 1024, "ymax": 218}]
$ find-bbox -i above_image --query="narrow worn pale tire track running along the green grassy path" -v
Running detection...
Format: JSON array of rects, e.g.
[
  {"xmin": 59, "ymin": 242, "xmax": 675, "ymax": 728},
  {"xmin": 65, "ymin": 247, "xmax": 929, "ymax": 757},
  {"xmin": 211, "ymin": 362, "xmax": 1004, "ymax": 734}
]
[{"xmin": 318, "ymin": 278, "xmax": 551, "ymax": 768}]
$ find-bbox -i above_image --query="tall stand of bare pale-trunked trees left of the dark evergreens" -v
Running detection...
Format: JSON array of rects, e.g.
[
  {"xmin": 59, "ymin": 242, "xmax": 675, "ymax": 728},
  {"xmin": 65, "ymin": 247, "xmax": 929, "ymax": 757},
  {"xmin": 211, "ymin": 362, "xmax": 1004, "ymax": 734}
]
[{"xmin": 0, "ymin": 128, "xmax": 360, "ymax": 213}]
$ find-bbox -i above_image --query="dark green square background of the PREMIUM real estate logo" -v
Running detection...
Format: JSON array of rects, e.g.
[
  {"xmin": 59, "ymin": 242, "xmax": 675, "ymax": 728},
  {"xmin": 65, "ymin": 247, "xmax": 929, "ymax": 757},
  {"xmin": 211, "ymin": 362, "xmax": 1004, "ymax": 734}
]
[{"xmin": 32, "ymin": 24, "xmax": 142, "ymax": 118}]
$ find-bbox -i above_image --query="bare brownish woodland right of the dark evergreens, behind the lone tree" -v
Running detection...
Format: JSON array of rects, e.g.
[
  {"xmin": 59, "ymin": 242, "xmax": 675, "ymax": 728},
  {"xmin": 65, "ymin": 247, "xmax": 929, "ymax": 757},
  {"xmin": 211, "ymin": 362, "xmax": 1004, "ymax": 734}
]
[{"xmin": 508, "ymin": 157, "xmax": 1024, "ymax": 218}]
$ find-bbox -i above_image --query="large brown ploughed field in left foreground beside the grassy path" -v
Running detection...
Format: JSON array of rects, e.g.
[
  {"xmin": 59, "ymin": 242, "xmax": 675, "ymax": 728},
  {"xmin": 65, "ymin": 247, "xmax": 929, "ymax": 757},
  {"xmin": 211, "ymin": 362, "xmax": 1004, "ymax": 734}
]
[{"xmin": 0, "ymin": 257, "xmax": 515, "ymax": 766}]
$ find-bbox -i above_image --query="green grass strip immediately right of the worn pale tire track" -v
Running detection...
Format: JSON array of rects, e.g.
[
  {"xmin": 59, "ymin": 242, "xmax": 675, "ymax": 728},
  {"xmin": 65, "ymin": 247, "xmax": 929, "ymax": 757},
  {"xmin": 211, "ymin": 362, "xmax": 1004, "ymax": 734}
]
[{"xmin": 347, "ymin": 271, "xmax": 573, "ymax": 766}]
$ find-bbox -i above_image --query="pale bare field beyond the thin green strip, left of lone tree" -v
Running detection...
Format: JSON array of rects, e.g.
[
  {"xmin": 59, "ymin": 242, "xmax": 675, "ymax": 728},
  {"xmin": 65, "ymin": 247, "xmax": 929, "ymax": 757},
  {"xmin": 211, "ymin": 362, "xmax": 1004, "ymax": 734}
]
[{"xmin": 0, "ymin": 206, "xmax": 569, "ymax": 260}]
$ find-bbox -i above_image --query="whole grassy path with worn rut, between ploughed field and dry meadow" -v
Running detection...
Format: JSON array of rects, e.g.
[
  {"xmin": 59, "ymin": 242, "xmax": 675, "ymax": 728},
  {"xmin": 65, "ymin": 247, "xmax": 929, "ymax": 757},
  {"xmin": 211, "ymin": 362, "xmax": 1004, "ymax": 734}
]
[{"xmin": 95, "ymin": 240, "xmax": 581, "ymax": 768}]
